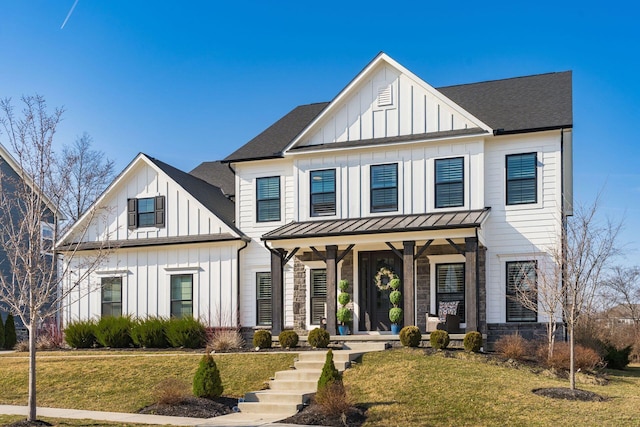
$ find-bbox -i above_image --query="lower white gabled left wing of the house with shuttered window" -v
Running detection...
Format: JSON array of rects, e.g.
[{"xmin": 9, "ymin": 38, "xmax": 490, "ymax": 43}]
[{"xmin": 58, "ymin": 154, "xmax": 248, "ymax": 326}]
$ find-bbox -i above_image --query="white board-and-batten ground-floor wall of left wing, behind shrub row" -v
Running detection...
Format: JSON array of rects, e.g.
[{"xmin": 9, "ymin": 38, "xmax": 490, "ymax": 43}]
[{"xmin": 64, "ymin": 242, "xmax": 240, "ymax": 326}]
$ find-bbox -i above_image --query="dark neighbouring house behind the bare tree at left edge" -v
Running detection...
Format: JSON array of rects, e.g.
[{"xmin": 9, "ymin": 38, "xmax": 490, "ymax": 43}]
[{"xmin": 0, "ymin": 144, "xmax": 62, "ymax": 332}]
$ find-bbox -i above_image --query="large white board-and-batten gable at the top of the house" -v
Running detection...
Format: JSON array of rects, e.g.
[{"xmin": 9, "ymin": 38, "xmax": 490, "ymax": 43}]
[{"xmin": 285, "ymin": 53, "xmax": 490, "ymax": 151}]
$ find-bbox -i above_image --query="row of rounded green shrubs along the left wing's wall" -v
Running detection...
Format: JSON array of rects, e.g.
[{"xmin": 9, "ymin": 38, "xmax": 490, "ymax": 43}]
[{"xmin": 64, "ymin": 316, "xmax": 206, "ymax": 348}]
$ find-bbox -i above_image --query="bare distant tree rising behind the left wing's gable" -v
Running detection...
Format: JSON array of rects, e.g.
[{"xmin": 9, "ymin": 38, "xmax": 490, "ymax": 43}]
[{"xmin": 58, "ymin": 132, "xmax": 114, "ymax": 225}]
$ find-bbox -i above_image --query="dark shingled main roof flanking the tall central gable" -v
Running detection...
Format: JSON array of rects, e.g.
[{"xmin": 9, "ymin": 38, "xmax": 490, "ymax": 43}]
[{"xmin": 223, "ymin": 71, "xmax": 573, "ymax": 163}]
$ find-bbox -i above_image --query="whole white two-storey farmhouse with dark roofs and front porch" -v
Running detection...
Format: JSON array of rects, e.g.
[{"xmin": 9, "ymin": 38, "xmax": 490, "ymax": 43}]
[{"xmin": 61, "ymin": 53, "xmax": 572, "ymax": 348}]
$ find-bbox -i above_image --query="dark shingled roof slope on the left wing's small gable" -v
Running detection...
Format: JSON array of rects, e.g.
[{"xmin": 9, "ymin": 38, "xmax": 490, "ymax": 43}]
[{"xmin": 146, "ymin": 156, "xmax": 244, "ymax": 236}]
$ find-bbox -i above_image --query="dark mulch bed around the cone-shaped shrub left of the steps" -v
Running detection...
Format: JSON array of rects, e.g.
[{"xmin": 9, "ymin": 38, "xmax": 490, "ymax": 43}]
[{"xmin": 138, "ymin": 396, "xmax": 238, "ymax": 418}]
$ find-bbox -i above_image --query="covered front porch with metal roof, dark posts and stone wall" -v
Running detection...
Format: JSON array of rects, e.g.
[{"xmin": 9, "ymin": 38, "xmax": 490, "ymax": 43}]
[{"xmin": 262, "ymin": 208, "xmax": 489, "ymax": 339}]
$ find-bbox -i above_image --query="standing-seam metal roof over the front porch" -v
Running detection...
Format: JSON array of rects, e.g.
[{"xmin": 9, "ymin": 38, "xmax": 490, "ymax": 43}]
[{"xmin": 262, "ymin": 208, "xmax": 491, "ymax": 241}]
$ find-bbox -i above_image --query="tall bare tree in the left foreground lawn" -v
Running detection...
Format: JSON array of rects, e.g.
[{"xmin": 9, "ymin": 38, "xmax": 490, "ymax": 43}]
[{"xmin": 0, "ymin": 96, "xmax": 108, "ymax": 421}]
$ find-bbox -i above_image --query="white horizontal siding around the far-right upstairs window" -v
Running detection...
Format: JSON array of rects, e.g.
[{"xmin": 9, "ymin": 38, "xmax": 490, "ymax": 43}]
[{"xmin": 482, "ymin": 131, "xmax": 562, "ymax": 323}]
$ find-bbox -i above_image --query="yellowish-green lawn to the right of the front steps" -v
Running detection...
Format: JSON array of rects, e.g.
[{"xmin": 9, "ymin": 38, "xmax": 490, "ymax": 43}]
[{"xmin": 345, "ymin": 349, "xmax": 640, "ymax": 426}]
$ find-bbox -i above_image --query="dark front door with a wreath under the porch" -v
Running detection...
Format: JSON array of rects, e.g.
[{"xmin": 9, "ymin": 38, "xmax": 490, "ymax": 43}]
[{"xmin": 358, "ymin": 251, "xmax": 402, "ymax": 331}]
